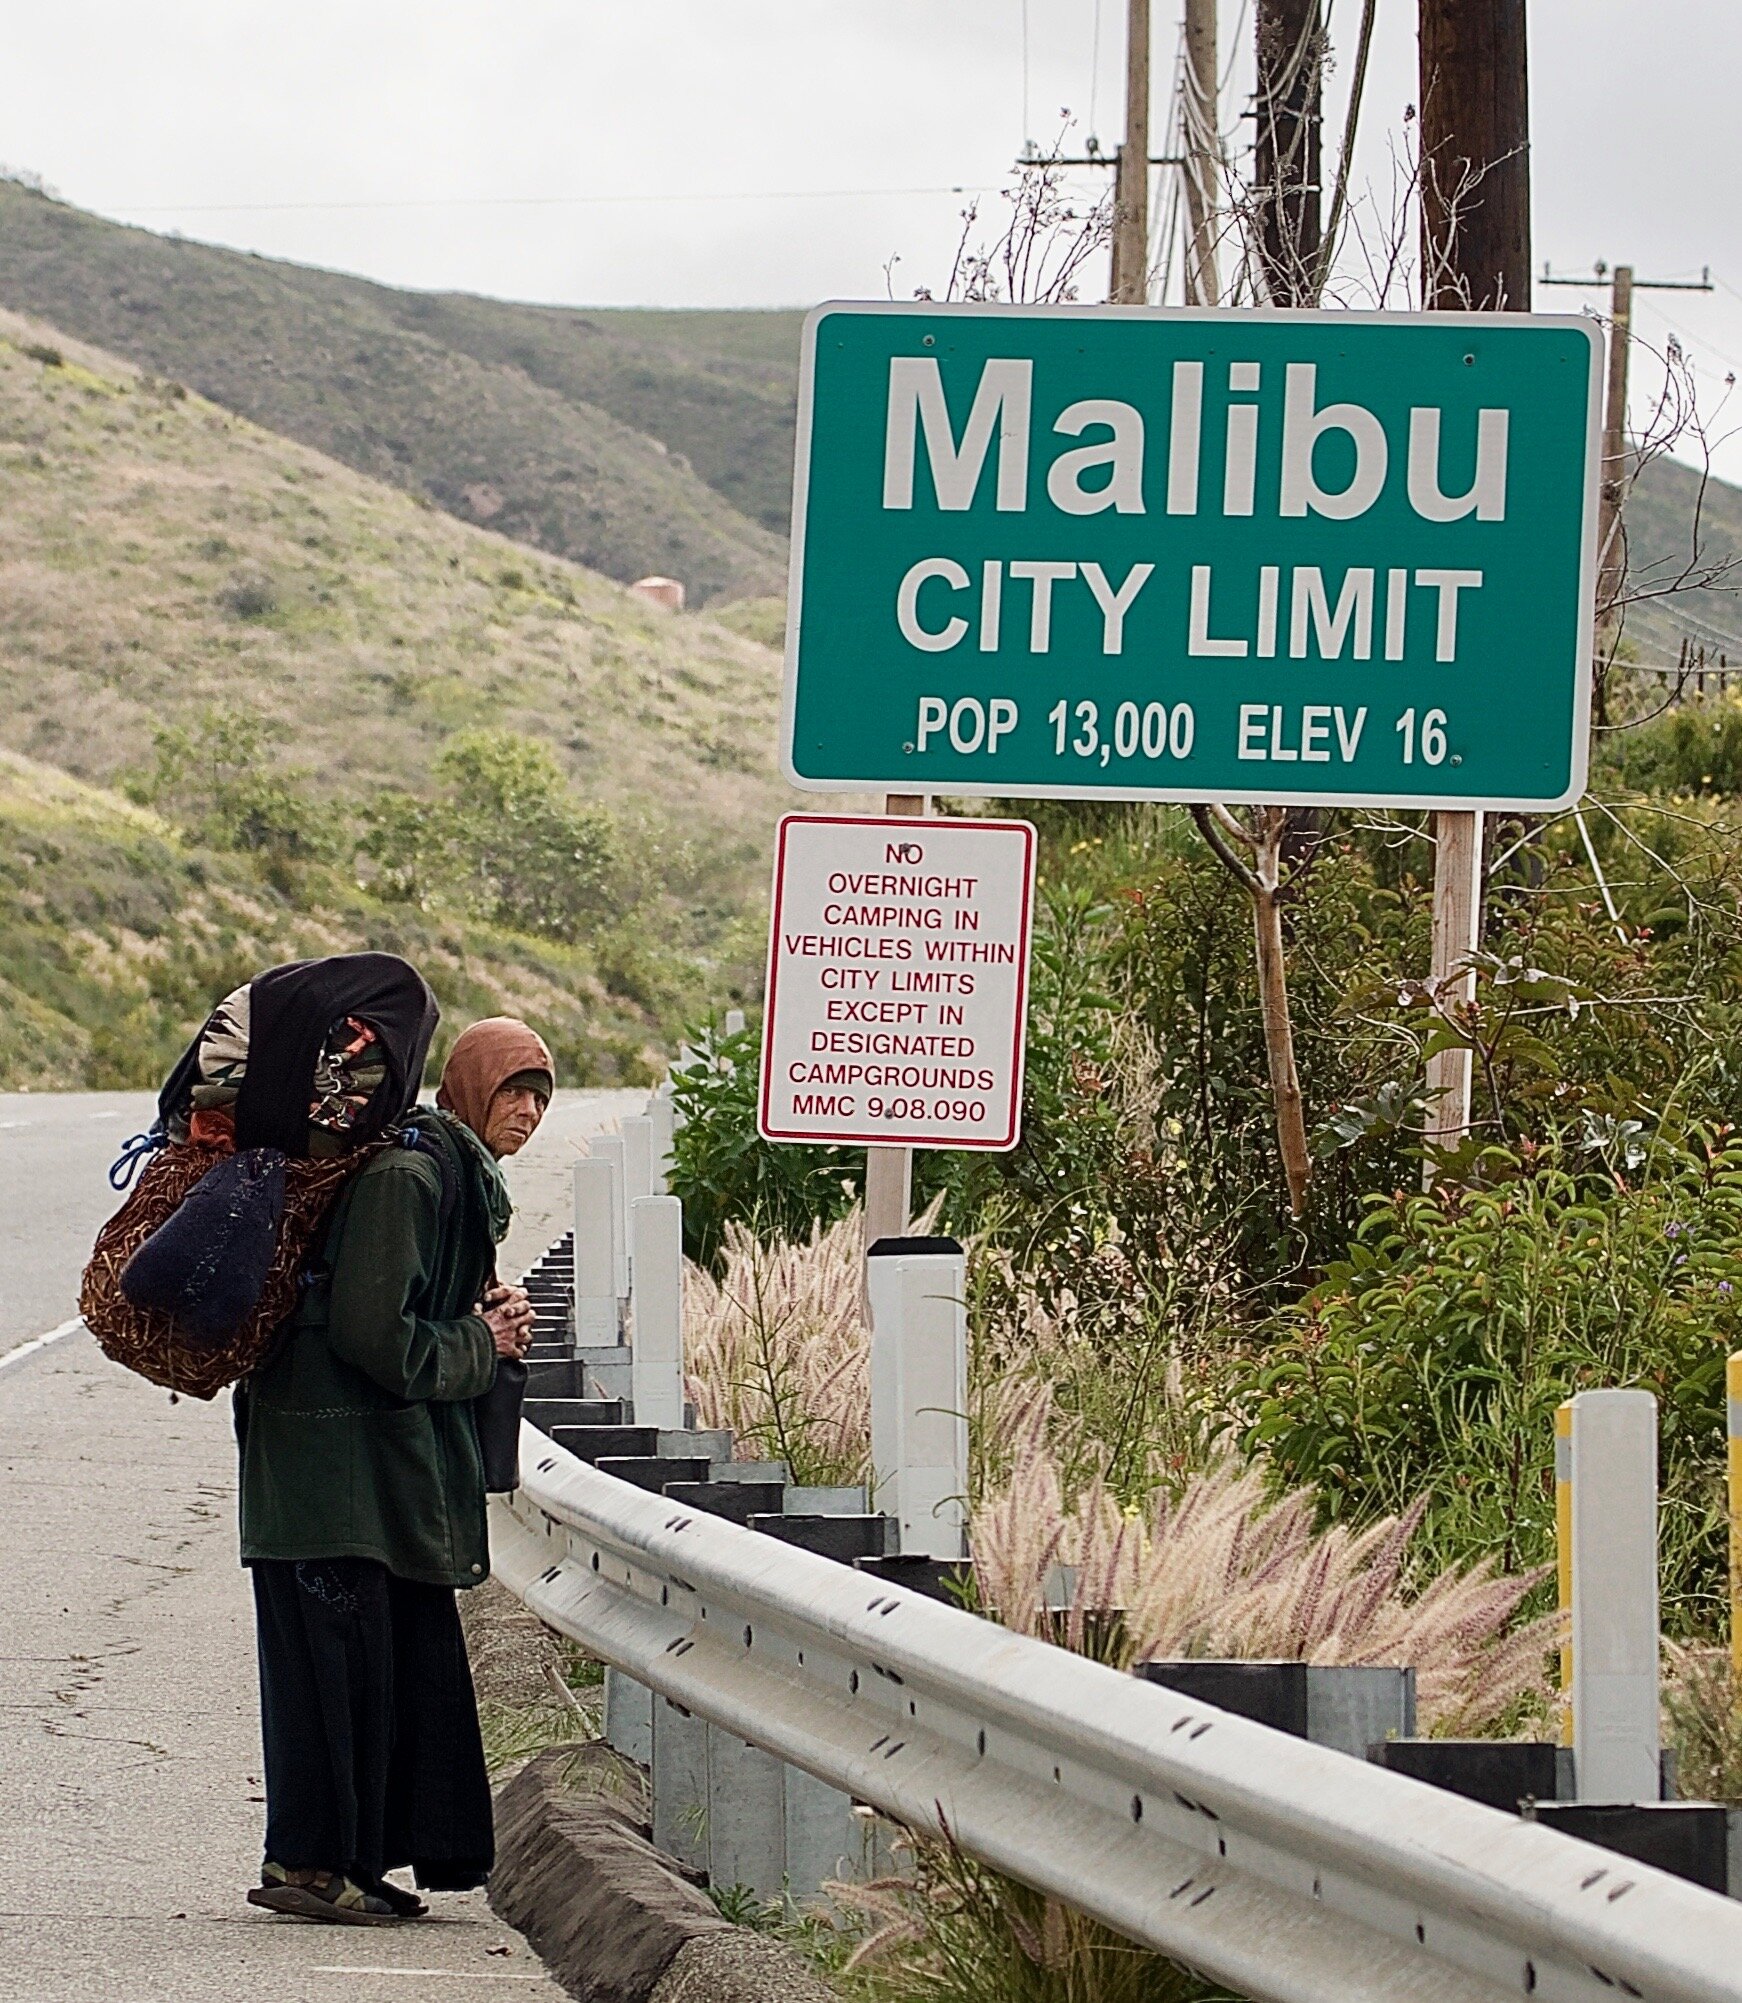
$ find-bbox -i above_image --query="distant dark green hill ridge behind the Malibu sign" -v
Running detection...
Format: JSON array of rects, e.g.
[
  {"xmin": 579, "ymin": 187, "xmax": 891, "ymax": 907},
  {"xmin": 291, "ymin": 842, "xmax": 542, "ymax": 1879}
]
[{"xmin": 0, "ymin": 180, "xmax": 1742, "ymax": 665}]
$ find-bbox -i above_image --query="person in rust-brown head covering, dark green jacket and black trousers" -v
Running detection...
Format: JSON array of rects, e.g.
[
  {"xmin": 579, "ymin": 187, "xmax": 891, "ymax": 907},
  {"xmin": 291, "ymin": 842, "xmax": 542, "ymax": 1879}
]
[{"xmin": 240, "ymin": 1020, "xmax": 555, "ymax": 1925}]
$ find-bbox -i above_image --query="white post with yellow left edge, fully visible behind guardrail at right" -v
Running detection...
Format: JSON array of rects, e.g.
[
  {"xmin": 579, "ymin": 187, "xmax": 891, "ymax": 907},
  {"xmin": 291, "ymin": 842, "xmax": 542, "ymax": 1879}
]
[{"xmin": 1572, "ymin": 1390, "xmax": 1662, "ymax": 1803}]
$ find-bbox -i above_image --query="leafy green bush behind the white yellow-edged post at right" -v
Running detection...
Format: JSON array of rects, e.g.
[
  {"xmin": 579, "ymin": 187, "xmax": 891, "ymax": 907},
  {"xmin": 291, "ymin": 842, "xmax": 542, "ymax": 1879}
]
[{"xmin": 1235, "ymin": 1116, "xmax": 1742, "ymax": 1630}]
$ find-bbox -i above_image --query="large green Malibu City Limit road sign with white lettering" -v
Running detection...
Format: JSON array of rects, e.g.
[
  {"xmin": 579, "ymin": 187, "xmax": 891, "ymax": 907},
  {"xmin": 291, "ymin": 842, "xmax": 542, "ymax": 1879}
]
[{"xmin": 785, "ymin": 302, "xmax": 1602, "ymax": 809}]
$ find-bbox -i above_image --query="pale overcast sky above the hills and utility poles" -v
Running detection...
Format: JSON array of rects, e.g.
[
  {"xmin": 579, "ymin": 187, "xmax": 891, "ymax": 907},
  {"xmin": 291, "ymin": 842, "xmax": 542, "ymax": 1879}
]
[{"xmin": 0, "ymin": 0, "xmax": 1742, "ymax": 481}]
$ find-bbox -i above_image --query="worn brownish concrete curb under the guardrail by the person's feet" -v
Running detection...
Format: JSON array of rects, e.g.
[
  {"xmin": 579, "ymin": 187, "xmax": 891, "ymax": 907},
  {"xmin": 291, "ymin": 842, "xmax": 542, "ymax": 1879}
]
[{"xmin": 491, "ymin": 1747, "xmax": 831, "ymax": 2003}]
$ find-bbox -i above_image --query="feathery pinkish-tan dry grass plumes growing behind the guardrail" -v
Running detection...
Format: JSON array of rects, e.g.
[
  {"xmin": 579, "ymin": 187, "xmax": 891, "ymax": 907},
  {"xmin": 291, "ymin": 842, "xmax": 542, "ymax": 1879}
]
[{"xmin": 685, "ymin": 1212, "xmax": 1556, "ymax": 1733}]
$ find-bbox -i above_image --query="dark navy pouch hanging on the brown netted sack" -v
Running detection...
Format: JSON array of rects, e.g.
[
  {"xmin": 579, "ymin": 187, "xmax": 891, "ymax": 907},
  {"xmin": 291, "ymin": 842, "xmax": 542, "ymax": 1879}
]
[{"xmin": 120, "ymin": 1148, "xmax": 284, "ymax": 1346}]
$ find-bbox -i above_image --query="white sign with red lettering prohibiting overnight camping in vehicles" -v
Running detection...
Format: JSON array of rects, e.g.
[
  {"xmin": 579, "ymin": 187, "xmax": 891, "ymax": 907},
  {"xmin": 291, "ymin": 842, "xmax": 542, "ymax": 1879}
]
[{"xmin": 757, "ymin": 813, "xmax": 1035, "ymax": 1150}]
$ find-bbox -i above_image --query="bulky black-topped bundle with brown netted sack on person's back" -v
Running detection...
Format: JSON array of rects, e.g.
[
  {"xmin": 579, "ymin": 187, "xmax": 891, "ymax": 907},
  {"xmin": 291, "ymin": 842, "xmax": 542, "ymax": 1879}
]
[{"xmin": 80, "ymin": 953, "xmax": 439, "ymax": 1398}]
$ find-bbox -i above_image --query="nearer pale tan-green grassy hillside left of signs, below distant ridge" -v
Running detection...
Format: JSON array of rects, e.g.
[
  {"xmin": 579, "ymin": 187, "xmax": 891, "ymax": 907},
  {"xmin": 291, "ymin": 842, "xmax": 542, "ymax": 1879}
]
[{"xmin": 0, "ymin": 314, "xmax": 791, "ymax": 1084}]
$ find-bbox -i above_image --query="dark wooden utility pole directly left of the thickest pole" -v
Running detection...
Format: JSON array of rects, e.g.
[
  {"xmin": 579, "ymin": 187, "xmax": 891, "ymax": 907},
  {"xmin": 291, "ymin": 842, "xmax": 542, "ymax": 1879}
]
[{"xmin": 1251, "ymin": 0, "xmax": 1326, "ymax": 306}]
